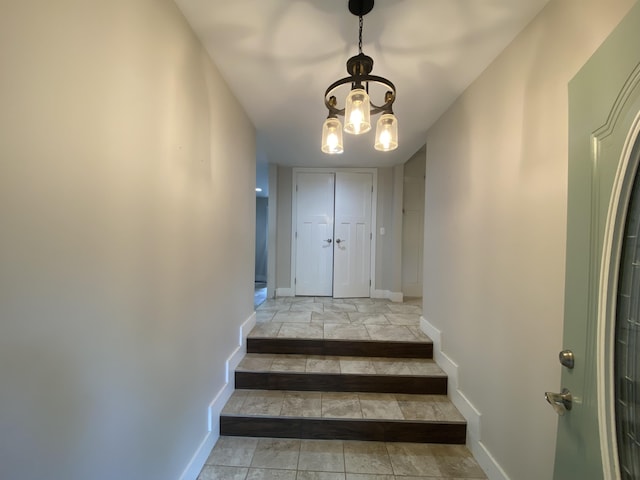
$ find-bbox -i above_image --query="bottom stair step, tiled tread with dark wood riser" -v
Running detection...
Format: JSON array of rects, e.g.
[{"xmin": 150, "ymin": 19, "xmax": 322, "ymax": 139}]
[{"xmin": 220, "ymin": 390, "xmax": 466, "ymax": 444}]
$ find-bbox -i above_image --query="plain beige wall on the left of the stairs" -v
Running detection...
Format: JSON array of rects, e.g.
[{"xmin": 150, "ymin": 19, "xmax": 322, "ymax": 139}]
[{"xmin": 0, "ymin": 0, "xmax": 255, "ymax": 480}]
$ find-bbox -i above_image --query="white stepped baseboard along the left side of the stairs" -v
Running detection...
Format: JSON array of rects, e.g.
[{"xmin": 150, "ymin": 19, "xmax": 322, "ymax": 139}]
[{"xmin": 180, "ymin": 312, "xmax": 256, "ymax": 480}]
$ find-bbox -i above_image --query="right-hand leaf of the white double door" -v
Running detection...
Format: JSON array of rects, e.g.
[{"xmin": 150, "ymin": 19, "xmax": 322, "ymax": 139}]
[{"xmin": 333, "ymin": 172, "xmax": 373, "ymax": 298}]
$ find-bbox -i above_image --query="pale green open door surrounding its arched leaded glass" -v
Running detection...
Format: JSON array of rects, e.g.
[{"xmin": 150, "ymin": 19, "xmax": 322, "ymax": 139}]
[{"xmin": 554, "ymin": 4, "xmax": 640, "ymax": 480}]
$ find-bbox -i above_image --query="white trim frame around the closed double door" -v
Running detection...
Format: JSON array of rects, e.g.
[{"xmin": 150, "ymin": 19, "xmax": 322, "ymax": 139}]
[{"xmin": 290, "ymin": 167, "xmax": 378, "ymax": 298}]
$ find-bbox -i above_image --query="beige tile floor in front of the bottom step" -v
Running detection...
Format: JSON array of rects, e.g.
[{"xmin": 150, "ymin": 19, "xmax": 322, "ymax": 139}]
[{"xmin": 198, "ymin": 437, "xmax": 487, "ymax": 480}]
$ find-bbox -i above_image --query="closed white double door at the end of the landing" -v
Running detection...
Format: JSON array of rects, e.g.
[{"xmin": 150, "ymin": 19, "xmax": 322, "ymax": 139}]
[{"xmin": 294, "ymin": 172, "xmax": 373, "ymax": 298}]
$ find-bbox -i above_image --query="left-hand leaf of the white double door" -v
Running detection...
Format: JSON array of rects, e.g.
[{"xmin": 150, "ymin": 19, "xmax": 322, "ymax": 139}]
[{"xmin": 295, "ymin": 172, "xmax": 335, "ymax": 296}]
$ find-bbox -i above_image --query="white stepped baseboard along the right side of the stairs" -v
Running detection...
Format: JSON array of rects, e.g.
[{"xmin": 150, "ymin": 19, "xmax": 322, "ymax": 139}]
[{"xmin": 420, "ymin": 317, "xmax": 510, "ymax": 480}]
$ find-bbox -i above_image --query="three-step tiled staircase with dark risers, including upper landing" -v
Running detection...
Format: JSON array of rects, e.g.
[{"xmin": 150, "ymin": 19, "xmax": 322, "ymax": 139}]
[{"xmin": 220, "ymin": 299, "xmax": 466, "ymax": 444}]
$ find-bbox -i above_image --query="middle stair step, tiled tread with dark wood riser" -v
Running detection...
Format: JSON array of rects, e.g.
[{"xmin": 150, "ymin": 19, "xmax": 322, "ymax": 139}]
[{"xmin": 235, "ymin": 353, "xmax": 447, "ymax": 395}]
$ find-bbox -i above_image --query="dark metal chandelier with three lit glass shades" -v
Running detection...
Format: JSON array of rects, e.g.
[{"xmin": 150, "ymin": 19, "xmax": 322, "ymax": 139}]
[{"xmin": 322, "ymin": 0, "xmax": 398, "ymax": 154}]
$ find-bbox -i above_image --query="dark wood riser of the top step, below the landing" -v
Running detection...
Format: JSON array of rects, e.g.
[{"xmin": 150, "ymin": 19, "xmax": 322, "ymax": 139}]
[{"xmin": 247, "ymin": 337, "xmax": 433, "ymax": 359}]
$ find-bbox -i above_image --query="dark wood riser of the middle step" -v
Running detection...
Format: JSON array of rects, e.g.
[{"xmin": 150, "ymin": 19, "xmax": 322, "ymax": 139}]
[{"xmin": 235, "ymin": 372, "xmax": 447, "ymax": 395}]
